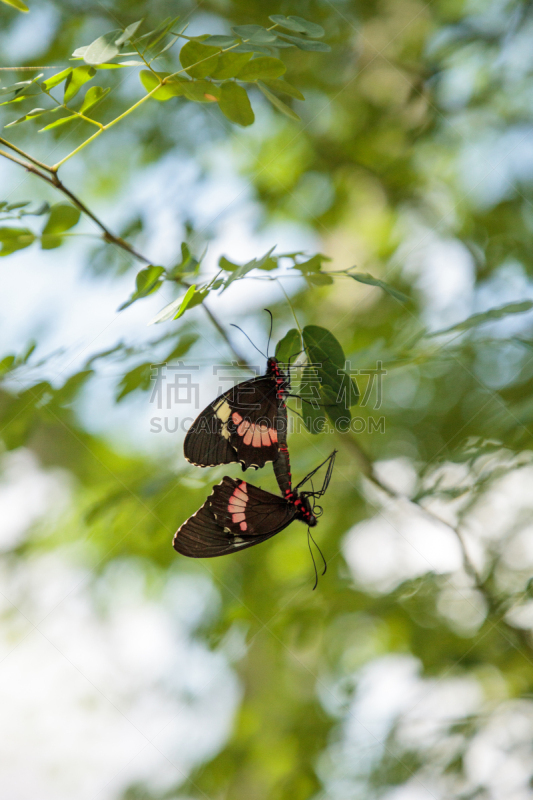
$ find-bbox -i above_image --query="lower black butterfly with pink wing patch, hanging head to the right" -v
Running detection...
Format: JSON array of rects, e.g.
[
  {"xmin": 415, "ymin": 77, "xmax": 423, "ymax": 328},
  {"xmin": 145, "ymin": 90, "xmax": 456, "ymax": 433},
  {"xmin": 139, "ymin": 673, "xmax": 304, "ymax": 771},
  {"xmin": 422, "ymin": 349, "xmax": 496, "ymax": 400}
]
[{"xmin": 172, "ymin": 451, "xmax": 336, "ymax": 558}]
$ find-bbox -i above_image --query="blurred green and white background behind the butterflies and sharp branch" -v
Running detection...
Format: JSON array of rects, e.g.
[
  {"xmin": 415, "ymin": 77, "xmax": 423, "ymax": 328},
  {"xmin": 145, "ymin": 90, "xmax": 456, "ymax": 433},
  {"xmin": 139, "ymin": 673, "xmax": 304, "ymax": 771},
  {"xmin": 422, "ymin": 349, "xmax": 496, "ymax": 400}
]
[{"xmin": 0, "ymin": 0, "xmax": 533, "ymax": 800}]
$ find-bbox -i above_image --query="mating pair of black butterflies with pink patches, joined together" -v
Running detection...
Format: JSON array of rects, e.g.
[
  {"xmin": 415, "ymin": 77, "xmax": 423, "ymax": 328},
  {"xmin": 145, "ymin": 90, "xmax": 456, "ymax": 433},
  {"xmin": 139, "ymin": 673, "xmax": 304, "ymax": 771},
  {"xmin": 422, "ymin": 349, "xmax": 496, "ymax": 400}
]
[{"xmin": 173, "ymin": 358, "xmax": 335, "ymax": 558}]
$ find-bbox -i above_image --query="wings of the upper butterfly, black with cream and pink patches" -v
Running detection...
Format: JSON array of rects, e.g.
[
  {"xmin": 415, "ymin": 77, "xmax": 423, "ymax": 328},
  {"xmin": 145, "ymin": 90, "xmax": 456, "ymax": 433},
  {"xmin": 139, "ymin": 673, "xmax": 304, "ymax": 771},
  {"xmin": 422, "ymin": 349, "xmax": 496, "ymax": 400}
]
[{"xmin": 184, "ymin": 375, "xmax": 287, "ymax": 470}]
